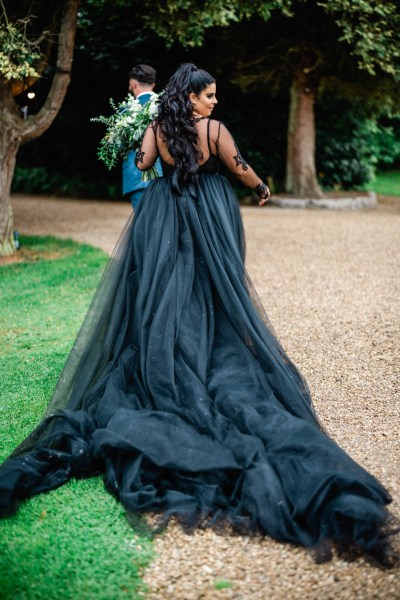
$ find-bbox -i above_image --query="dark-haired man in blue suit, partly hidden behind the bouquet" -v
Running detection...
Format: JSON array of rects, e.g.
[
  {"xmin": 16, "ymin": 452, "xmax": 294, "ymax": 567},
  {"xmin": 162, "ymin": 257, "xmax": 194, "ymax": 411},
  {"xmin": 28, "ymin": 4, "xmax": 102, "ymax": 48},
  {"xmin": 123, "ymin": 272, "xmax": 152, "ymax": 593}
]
[{"xmin": 122, "ymin": 65, "xmax": 161, "ymax": 209}]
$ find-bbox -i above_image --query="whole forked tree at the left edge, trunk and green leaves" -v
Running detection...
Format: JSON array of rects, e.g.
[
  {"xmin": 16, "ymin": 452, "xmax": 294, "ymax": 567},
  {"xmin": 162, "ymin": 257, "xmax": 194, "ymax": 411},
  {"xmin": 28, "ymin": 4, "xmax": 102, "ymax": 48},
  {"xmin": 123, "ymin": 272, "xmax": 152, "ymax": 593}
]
[{"xmin": 0, "ymin": 0, "xmax": 79, "ymax": 255}]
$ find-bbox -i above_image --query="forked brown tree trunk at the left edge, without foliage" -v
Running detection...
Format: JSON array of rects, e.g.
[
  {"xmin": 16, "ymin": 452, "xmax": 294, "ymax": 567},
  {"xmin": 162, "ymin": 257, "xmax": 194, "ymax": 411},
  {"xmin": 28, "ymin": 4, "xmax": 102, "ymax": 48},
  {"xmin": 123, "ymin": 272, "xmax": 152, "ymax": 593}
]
[{"xmin": 0, "ymin": 0, "xmax": 79, "ymax": 256}]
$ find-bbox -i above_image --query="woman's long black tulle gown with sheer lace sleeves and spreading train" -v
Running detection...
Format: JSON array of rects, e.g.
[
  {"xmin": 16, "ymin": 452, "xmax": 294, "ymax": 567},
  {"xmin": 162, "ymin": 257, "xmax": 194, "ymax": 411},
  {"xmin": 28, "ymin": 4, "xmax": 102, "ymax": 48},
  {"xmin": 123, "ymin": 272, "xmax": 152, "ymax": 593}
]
[{"xmin": 0, "ymin": 120, "xmax": 390, "ymax": 564}]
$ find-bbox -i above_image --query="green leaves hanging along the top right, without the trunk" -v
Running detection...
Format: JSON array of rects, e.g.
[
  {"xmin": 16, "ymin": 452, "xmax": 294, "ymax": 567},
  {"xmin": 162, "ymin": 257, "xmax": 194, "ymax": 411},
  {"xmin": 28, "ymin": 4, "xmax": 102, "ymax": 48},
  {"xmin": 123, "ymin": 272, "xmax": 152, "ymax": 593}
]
[{"xmin": 142, "ymin": 0, "xmax": 400, "ymax": 80}]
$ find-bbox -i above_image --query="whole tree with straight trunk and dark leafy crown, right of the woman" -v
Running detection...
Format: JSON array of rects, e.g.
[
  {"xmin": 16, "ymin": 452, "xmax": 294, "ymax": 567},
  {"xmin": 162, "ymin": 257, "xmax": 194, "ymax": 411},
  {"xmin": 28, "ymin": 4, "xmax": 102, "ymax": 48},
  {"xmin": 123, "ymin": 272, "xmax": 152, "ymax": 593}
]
[{"xmin": 142, "ymin": 0, "xmax": 400, "ymax": 197}]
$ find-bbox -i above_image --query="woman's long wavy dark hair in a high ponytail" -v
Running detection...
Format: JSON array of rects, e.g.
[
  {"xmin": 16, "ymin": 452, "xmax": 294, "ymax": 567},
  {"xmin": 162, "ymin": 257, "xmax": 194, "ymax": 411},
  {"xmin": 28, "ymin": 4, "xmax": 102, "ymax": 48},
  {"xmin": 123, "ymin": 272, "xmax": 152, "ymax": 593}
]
[{"xmin": 157, "ymin": 63, "xmax": 215, "ymax": 185}]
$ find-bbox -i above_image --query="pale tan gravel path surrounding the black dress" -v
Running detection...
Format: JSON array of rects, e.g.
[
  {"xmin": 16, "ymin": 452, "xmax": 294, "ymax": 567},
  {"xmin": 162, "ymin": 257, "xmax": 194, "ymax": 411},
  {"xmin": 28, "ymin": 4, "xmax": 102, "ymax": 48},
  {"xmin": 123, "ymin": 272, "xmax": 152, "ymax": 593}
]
[{"xmin": 13, "ymin": 196, "xmax": 400, "ymax": 600}]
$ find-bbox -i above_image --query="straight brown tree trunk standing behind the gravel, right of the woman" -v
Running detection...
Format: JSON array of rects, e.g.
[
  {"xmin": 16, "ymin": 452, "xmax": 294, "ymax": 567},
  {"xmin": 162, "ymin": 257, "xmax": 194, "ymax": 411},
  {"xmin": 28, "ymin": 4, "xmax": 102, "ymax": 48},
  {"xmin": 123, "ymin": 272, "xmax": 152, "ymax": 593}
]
[{"xmin": 285, "ymin": 68, "xmax": 323, "ymax": 198}]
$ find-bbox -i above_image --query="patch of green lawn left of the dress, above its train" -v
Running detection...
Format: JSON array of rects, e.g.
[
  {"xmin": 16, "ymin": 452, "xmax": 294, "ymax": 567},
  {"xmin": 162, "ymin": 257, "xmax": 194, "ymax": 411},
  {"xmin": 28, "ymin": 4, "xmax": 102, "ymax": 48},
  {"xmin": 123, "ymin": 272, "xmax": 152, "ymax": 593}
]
[{"xmin": 0, "ymin": 237, "xmax": 108, "ymax": 458}]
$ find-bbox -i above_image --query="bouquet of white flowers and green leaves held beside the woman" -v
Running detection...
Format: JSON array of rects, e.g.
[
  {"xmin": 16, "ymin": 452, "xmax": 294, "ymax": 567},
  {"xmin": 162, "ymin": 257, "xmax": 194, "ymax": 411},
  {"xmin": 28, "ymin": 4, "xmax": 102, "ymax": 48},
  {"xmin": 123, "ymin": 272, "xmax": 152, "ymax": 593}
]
[{"xmin": 90, "ymin": 92, "xmax": 162, "ymax": 181}]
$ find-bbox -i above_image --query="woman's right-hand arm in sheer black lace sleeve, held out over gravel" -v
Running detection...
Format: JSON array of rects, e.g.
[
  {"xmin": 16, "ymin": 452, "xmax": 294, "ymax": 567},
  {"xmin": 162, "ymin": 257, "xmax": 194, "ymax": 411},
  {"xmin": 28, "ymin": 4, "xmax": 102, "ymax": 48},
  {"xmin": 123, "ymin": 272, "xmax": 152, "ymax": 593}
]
[{"xmin": 216, "ymin": 123, "xmax": 271, "ymax": 206}]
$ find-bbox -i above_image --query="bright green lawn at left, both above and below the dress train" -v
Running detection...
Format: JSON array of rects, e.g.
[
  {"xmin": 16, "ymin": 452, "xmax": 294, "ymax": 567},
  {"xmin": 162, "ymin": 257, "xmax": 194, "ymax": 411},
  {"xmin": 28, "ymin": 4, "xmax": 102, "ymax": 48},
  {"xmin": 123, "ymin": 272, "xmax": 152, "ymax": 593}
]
[{"xmin": 0, "ymin": 238, "xmax": 152, "ymax": 600}]
